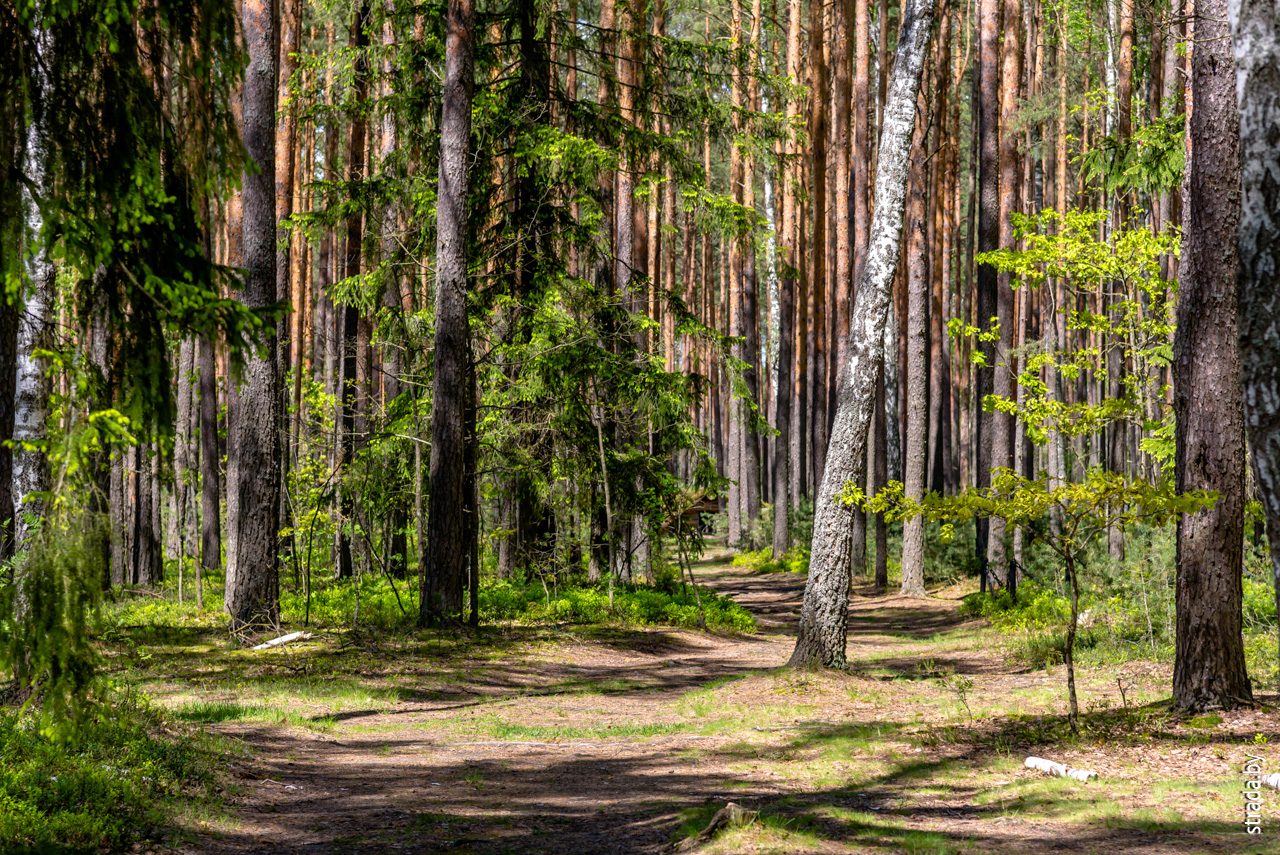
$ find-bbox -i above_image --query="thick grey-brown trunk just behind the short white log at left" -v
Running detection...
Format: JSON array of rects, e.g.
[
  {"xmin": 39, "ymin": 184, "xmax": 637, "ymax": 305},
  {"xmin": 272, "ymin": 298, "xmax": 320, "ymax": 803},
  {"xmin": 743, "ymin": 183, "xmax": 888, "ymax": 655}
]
[{"xmin": 227, "ymin": 0, "xmax": 284, "ymax": 631}]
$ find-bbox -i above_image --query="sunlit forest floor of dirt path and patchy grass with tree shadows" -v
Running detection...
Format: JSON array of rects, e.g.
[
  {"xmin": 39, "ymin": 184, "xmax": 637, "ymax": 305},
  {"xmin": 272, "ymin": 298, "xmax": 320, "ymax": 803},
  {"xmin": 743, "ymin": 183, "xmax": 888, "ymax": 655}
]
[{"xmin": 122, "ymin": 555, "xmax": 1280, "ymax": 855}]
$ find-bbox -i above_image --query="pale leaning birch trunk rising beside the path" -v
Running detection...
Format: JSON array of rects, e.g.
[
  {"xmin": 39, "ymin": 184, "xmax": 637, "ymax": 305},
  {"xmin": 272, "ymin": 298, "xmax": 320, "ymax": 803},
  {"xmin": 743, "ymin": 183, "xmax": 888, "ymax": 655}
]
[{"xmin": 790, "ymin": 0, "xmax": 933, "ymax": 668}]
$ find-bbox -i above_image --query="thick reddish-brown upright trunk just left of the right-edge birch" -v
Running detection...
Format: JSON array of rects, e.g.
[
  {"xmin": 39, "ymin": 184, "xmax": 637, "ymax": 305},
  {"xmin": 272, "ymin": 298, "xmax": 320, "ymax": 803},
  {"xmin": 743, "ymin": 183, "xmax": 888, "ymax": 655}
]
[{"xmin": 1174, "ymin": 0, "xmax": 1253, "ymax": 710}]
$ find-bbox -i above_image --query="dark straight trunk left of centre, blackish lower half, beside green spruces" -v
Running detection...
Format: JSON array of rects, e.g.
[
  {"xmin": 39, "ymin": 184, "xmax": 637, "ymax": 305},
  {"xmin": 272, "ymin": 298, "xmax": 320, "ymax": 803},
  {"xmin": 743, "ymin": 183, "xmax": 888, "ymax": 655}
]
[{"xmin": 419, "ymin": 0, "xmax": 476, "ymax": 625}]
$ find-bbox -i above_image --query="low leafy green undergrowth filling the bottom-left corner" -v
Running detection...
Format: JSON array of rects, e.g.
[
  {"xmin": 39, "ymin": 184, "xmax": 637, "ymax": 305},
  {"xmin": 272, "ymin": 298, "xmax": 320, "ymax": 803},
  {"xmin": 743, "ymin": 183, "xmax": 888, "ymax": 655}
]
[{"xmin": 0, "ymin": 696, "xmax": 214, "ymax": 851}]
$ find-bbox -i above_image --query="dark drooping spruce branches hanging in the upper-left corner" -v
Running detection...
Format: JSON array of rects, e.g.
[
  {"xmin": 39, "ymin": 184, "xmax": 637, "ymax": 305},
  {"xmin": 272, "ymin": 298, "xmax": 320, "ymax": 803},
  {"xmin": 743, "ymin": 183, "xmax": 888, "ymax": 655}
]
[{"xmin": 8, "ymin": 0, "xmax": 272, "ymax": 434}]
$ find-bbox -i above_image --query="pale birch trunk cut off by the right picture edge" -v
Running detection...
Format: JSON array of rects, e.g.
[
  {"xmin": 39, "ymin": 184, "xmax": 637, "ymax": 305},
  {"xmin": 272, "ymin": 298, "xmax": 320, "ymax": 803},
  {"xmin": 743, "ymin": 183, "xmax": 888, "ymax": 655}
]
[{"xmin": 1231, "ymin": 0, "xmax": 1280, "ymax": 696}]
